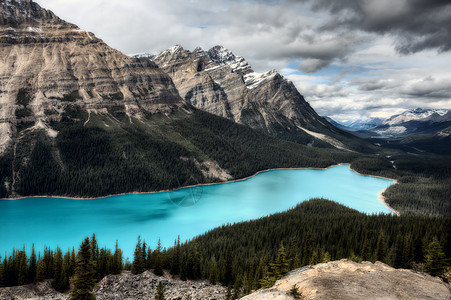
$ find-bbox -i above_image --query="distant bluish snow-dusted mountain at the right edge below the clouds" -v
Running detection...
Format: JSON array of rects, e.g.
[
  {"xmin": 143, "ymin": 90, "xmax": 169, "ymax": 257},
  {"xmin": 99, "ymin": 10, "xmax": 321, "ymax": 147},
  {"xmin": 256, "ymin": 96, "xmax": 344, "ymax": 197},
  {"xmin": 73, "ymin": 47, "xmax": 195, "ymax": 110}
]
[{"xmin": 369, "ymin": 108, "xmax": 451, "ymax": 137}]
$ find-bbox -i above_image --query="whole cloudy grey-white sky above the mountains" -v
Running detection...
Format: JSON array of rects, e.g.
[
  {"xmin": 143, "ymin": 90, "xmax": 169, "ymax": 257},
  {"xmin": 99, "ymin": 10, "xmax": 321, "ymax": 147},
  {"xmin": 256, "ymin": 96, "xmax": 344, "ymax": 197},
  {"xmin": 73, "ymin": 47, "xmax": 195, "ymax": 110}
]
[{"xmin": 36, "ymin": 0, "xmax": 451, "ymax": 121}]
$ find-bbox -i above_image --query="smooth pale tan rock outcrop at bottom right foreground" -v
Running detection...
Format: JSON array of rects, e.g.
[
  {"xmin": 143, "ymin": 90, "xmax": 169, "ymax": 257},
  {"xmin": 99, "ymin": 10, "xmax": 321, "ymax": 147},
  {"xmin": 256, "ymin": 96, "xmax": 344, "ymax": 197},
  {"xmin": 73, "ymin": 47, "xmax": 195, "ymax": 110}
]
[{"xmin": 242, "ymin": 259, "xmax": 451, "ymax": 300}]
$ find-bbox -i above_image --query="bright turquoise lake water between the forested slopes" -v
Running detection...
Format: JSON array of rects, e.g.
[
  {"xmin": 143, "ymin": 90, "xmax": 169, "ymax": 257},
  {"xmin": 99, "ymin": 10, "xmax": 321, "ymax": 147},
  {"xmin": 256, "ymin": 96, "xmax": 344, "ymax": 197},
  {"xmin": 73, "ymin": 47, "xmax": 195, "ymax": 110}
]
[{"xmin": 0, "ymin": 165, "xmax": 393, "ymax": 260}]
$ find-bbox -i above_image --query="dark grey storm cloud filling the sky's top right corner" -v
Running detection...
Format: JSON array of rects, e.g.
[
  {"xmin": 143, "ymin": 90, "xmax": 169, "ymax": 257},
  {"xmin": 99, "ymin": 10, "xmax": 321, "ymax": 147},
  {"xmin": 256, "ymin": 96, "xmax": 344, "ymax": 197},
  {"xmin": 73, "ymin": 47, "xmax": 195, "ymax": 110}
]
[{"xmin": 301, "ymin": 0, "xmax": 451, "ymax": 54}]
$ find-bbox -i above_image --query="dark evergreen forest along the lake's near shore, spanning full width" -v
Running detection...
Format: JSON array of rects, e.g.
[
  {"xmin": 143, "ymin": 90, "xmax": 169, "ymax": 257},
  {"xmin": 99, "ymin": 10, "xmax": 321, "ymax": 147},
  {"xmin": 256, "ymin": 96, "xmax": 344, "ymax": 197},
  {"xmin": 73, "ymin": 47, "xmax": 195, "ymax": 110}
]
[{"xmin": 0, "ymin": 199, "xmax": 451, "ymax": 299}]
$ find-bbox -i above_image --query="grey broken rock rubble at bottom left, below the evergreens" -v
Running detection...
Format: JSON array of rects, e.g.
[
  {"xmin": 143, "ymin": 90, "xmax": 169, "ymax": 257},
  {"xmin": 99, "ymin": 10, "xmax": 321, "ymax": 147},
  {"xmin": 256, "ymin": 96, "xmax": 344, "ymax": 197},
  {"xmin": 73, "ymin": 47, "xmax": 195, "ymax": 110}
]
[{"xmin": 0, "ymin": 271, "xmax": 227, "ymax": 300}]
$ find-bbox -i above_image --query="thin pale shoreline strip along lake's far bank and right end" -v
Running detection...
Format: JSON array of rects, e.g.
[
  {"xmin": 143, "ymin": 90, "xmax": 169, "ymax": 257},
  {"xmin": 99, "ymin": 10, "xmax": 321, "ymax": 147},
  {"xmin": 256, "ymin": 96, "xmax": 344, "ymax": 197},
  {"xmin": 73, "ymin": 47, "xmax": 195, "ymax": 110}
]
[{"xmin": 0, "ymin": 163, "xmax": 400, "ymax": 216}]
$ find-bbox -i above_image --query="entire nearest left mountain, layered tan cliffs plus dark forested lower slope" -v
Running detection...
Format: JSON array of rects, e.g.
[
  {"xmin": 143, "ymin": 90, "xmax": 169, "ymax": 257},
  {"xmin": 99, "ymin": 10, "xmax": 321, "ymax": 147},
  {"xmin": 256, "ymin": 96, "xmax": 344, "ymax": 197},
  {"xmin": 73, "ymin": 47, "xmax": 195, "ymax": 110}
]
[{"xmin": 0, "ymin": 0, "xmax": 357, "ymax": 197}]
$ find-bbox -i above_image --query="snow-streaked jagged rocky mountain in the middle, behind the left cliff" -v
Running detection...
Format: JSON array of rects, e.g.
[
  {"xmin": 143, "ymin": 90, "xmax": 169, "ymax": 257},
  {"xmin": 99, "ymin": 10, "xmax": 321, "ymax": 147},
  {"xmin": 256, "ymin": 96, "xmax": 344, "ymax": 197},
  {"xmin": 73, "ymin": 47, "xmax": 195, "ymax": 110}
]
[{"xmin": 146, "ymin": 45, "xmax": 374, "ymax": 150}]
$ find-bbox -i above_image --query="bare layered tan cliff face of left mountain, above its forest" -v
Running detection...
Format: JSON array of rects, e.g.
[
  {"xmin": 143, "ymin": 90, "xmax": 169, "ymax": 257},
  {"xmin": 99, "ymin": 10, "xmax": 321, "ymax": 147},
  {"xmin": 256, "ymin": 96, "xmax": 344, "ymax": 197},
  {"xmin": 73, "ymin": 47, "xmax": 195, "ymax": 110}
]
[{"xmin": 0, "ymin": 0, "xmax": 183, "ymax": 152}]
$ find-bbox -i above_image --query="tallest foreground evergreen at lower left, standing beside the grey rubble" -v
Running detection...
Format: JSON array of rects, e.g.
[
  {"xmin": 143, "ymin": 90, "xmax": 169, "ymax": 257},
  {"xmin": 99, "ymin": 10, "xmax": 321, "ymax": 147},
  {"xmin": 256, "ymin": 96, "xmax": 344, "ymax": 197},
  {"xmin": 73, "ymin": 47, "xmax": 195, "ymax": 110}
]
[{"xmin": 70, "ymin": 237, "xmax": 96, "ymax": 300}]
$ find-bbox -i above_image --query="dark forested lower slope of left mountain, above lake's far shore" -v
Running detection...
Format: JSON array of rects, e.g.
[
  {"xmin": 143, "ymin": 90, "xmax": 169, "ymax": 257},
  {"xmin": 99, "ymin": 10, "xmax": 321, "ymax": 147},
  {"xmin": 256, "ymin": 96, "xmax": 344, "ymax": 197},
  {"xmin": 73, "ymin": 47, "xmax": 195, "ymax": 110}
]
[{"xmin": 0, "ymin": 106, "xmax": 359, "ymax": 197}]
